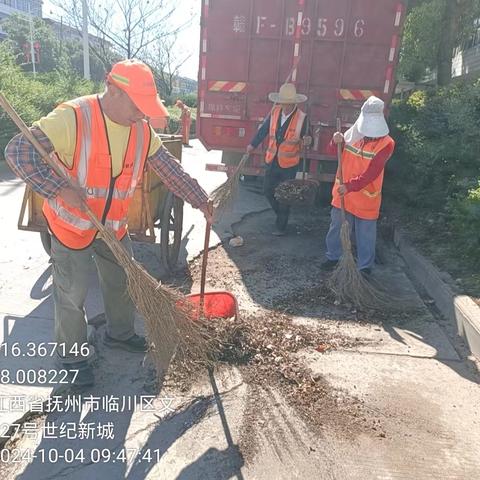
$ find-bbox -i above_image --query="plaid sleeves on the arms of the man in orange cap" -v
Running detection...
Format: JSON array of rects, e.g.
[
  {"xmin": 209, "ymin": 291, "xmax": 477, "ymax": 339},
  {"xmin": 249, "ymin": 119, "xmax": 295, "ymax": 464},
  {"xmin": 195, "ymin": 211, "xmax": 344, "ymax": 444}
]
[{"xmin": 5, "ymin": 127, "xmax": 208, "ymax": 208}]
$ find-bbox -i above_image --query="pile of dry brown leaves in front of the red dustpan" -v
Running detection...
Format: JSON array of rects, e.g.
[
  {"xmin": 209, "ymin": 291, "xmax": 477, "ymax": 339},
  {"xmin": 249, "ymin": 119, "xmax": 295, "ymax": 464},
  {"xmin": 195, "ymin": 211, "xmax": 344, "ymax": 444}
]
[{"xmin": 169, "ymin": 311, "xmax": 370, "ymax": 436}]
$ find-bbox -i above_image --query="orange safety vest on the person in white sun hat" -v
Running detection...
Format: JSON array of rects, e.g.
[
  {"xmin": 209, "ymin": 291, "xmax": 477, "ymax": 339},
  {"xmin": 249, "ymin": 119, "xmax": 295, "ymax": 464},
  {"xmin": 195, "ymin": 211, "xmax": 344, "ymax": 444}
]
[{"xmin": 332, "ymin": 135, "xmax": 395, "ymax": 220}]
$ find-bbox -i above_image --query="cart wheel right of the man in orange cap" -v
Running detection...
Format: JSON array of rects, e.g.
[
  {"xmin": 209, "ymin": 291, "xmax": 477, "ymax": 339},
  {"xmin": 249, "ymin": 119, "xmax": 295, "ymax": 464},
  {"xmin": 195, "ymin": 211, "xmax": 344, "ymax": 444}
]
[{"xmin": 160, "ymin": 192, "xmax": 183, "ymax": 270}]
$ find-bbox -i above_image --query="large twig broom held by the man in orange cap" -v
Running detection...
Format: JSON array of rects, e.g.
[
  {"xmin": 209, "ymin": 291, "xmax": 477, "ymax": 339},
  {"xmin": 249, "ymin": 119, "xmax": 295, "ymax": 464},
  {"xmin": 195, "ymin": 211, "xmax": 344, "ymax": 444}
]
[{"xmin": 0, "ymin": 92, "xmax": 210, "ymax": 376}]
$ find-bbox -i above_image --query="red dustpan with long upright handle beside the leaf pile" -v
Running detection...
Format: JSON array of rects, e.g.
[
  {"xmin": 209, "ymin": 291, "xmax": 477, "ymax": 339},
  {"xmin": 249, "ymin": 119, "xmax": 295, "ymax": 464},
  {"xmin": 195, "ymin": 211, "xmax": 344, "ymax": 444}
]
[{"xmin": 186, "ymin": 204, "xmax": 238, "ymax": 320}]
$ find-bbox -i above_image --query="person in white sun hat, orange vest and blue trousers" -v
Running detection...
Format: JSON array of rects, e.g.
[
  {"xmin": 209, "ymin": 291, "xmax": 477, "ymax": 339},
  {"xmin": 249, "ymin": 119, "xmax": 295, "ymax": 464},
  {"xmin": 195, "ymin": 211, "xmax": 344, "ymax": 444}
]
[{"xmin": 322, "ymin": 96, "xmax": 395, "ymax": 275}]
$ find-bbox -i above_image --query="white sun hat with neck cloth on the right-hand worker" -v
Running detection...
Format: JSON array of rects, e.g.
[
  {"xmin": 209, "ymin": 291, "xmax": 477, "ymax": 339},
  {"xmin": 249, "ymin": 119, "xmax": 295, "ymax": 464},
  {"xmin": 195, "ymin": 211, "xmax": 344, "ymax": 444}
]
[{"xmin": 344, "ymin": 96, "xmax": 390, "ymax": 145}]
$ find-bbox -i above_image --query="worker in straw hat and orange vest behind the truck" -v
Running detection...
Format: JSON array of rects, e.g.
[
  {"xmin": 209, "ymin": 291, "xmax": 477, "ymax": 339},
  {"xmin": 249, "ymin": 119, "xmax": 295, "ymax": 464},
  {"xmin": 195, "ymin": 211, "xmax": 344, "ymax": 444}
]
[{"xmin": 246, "ymin": 83, "xmax": 312, "ymax": 236}]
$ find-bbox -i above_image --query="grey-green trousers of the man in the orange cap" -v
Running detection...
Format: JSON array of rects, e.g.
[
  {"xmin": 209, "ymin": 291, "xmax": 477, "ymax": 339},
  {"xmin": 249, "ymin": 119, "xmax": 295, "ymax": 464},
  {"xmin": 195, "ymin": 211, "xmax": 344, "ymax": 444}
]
[{"xmin": 51, "ymin": 235, "xmax": 135, "ymax": 363}]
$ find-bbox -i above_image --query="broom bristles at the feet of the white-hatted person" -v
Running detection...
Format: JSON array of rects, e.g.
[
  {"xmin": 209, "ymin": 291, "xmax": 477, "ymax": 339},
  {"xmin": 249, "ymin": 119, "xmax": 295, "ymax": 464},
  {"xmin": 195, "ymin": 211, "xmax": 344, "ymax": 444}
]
[{"xmin": 328, "ymin": 220, "xmax": 395, "ymax": 310}]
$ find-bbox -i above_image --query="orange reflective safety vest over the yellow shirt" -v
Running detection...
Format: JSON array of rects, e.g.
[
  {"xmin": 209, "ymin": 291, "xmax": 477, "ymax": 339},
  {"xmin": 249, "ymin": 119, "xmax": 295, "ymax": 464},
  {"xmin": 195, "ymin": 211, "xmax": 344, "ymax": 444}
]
[{"xmin": 43, "ymin": 95, "xmax": 150, "ymax": 250}]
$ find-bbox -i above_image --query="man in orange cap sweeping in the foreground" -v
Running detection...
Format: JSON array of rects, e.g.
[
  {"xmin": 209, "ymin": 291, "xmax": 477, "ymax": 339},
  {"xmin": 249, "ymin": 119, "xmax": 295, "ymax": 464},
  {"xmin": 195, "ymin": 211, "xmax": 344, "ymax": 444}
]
[{"xmin": 5, "ymin": 60, "xmax": 212, "ymax": 386}]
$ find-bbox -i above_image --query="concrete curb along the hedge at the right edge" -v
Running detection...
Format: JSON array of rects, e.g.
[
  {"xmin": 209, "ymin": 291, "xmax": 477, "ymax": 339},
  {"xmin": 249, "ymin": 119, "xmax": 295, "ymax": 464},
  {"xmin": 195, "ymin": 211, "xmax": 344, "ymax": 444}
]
[{"xmin": 393, "ymin": 227, "xmax": 480, "ymax": 360}]
